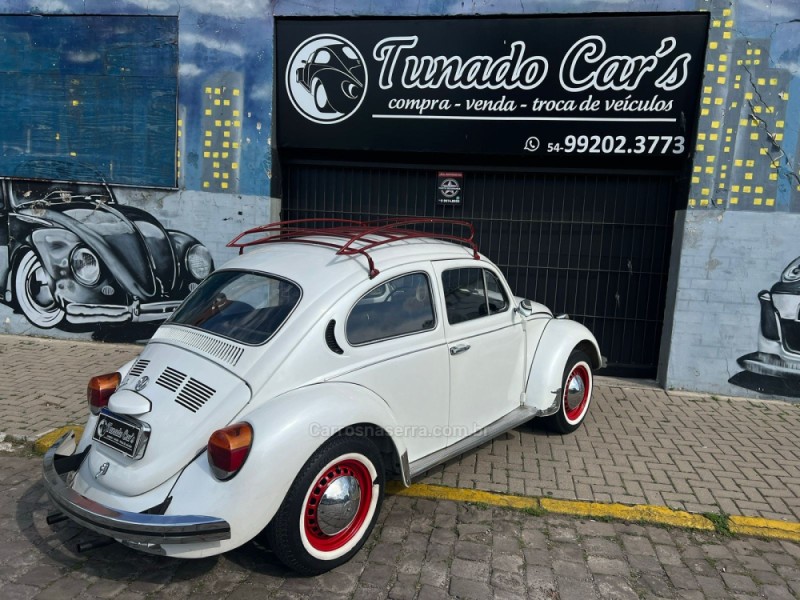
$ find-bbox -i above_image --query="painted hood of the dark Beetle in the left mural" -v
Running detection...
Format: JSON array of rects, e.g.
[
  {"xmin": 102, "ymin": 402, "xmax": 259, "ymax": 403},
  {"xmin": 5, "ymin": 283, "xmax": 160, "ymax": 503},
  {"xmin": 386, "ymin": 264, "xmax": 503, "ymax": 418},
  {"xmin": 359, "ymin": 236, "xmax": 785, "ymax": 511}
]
[{"xmin": 17, "ymin": 201, "xmax": 177, "ymax": 299}]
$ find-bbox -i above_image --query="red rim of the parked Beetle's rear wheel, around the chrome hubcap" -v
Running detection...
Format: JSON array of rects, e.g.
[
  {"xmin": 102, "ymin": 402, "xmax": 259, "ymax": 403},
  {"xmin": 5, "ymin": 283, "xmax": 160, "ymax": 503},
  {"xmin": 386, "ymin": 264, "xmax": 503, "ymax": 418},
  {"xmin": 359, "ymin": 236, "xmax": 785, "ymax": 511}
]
[{"xmin": 303, "ymin": 459, "xmax": 372, "ymax": 552}]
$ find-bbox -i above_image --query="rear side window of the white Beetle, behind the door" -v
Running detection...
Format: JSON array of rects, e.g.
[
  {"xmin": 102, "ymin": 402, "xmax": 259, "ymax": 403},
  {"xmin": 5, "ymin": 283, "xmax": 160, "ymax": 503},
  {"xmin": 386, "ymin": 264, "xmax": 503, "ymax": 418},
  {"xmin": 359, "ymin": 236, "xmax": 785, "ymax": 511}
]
[{"xmin": 345, "ymin": 273, "xmax": 436, "ymax": 345}]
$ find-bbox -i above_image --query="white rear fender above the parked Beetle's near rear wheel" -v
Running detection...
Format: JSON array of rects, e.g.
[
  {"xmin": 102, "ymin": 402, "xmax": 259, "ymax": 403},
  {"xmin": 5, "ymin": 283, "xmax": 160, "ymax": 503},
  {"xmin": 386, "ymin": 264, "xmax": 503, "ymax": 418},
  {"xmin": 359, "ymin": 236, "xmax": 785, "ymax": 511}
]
[{"xmin": 167, "ymin": 383, "xmax": 406, "ymax": 556}]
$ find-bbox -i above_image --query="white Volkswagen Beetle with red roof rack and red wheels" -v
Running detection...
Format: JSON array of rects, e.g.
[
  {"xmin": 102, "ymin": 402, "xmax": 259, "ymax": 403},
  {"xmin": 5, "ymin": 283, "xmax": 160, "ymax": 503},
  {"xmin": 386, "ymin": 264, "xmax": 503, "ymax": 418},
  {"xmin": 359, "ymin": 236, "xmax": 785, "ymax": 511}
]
[{"xmin": 44, "ymin": 219, "xmax": 602, "ymax": 573}]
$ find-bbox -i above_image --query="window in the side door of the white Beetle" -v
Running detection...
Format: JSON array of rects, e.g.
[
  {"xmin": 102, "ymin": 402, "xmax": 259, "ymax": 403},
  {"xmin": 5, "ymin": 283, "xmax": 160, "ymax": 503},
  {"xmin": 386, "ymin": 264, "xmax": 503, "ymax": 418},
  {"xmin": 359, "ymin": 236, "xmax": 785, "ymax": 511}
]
[{"xmin": 442, "ymin": 267, "xmax": 508, "ymax": 325}]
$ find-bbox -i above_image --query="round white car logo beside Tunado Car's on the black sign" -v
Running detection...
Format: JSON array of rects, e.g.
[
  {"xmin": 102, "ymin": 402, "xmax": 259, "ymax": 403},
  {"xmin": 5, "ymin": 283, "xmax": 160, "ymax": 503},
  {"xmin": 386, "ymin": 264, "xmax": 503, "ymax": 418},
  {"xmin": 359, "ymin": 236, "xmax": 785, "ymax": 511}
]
[{"xmin": 286, "ymin": 33, "xmax": 367, "ymax": 125}]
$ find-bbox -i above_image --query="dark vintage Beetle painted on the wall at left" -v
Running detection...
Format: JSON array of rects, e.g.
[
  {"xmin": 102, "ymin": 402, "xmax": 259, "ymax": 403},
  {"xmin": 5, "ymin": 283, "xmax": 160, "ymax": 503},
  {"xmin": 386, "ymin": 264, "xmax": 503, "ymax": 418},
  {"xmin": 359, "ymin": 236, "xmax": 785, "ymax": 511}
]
[{"xmin": 0, "ymin": 177, "xmax": 214, "ymax": 329}]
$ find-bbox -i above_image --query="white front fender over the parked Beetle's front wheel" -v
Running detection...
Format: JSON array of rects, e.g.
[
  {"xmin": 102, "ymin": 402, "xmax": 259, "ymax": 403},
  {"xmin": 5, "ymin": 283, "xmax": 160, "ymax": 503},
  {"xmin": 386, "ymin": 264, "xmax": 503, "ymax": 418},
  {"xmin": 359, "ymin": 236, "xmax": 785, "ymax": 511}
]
[{"xmin": 525, "ymin": 318, "xmax": 603, "ymax": 415}]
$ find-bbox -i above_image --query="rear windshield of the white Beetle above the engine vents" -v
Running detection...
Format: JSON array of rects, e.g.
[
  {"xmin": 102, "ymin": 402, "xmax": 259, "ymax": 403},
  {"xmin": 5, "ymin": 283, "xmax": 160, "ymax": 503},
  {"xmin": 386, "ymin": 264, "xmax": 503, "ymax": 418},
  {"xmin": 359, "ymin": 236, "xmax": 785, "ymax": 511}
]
[{"xmin": 170, "ymin": 271, "xmax": 301, "ymax": 344}]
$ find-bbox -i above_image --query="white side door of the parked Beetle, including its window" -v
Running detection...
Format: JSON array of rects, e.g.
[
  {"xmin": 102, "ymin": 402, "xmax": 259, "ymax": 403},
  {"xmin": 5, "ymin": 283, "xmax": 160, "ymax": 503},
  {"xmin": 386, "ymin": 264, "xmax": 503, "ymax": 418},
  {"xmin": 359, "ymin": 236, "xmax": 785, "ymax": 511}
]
[{"xmin": 436, "ymin": 260, "xmax": 525, "ymax": 444}]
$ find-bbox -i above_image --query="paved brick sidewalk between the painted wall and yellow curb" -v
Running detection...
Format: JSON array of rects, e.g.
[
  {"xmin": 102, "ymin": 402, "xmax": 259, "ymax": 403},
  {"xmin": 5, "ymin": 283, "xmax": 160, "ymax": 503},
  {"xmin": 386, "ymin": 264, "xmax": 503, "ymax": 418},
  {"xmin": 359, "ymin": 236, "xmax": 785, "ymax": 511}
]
[{"xmin": 0, "ymin": 335, "xmax": 800, "ymax": 522}]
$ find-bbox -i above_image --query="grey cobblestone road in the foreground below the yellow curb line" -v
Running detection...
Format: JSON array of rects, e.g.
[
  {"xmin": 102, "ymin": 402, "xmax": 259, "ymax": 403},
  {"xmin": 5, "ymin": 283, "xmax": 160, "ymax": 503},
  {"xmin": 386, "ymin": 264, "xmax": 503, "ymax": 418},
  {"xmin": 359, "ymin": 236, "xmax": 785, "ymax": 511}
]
[{"xmin": 0, "ymin": 456, "xmax": 800, "ymax": 600}]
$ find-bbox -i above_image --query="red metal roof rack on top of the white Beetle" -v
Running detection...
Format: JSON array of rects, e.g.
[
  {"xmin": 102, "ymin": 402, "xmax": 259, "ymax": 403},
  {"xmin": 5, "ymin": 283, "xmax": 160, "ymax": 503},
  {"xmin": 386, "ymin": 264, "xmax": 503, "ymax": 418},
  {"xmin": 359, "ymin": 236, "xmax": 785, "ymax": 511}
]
[{"xmin": 228, "ymin": 217, "xmax": 480, "ymax": 279}]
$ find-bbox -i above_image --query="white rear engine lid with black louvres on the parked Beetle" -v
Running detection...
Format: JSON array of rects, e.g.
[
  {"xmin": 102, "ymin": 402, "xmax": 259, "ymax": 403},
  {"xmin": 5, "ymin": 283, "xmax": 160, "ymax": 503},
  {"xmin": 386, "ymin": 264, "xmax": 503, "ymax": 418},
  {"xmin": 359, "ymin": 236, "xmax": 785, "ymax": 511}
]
[{"xmin": 78, "ymin": 342, "xmax": 251, "ymax": 496}]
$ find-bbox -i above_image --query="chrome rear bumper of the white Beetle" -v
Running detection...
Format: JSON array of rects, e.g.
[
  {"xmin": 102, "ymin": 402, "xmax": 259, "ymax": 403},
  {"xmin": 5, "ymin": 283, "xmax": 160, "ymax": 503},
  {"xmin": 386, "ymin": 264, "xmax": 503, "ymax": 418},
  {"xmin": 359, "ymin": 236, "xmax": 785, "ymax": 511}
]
[{"xmin": 43, "ymin": 433, "xmax": 231, "ymax": 549}]
